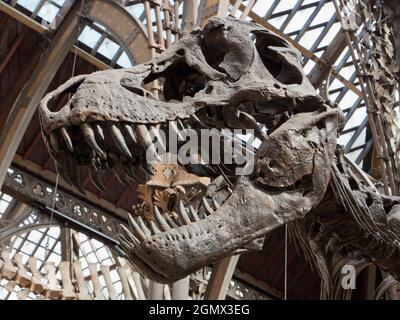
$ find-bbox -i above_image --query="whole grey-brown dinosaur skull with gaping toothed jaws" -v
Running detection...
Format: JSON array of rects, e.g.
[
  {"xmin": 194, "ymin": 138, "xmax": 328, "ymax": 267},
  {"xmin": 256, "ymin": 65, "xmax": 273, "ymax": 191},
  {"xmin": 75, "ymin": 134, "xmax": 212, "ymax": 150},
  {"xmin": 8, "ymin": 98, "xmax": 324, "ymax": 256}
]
[{"xmin": 39, "ymin": 18, "xmax": 340, "ymax": 282}]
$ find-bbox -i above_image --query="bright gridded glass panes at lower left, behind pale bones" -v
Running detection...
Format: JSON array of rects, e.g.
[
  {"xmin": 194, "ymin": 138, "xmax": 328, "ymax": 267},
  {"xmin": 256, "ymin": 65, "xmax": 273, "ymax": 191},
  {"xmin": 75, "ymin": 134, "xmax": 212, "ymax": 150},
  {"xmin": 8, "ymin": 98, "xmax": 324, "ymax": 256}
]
[{"xmin": 0, "ymin": 193, "xmax": 124, "ymax": 300}]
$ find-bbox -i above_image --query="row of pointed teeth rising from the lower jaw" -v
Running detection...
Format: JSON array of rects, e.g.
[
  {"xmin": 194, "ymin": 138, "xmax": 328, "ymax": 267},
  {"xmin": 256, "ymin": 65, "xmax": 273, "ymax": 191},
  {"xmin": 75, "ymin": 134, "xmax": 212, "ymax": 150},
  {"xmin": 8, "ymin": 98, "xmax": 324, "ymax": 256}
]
[{"xmin": 121, "ymin": 197, "xmax": 220, "ymax": 250}]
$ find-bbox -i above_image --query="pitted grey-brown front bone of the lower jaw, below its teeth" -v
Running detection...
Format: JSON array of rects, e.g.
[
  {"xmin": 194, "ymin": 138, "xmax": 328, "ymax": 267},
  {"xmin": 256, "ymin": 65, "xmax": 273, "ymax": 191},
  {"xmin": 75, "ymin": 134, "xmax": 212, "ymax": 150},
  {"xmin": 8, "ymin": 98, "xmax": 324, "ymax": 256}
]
[{"xmin": 130, "ymin": 178, "xmax": 283, "ymax": 283}]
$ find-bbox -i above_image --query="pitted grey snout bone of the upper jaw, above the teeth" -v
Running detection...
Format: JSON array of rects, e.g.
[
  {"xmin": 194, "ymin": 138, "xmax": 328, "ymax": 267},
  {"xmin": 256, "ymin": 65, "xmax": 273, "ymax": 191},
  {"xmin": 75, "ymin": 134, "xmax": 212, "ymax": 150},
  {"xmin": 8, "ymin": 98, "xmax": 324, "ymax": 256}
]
[{"xmin": 39, "ymin": 70, "xmax": 195, "ymax": 135}]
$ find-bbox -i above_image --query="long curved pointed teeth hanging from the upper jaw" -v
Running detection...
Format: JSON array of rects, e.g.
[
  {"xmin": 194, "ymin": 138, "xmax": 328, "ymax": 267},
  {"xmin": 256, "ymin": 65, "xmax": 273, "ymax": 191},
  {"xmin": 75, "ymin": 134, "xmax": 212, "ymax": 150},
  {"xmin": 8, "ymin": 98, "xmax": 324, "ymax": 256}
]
[{"xmin": 49, "ymin": 121, "xmax": 188, "ymax": 192}]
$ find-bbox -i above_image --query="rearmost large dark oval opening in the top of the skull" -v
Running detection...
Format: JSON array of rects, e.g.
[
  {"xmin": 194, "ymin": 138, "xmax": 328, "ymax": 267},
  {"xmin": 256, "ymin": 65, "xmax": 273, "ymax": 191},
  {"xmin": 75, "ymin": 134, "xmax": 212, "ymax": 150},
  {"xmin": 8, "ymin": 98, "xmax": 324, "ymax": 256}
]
[{"xmin": 254, "ymin": 31, "xmax": 303, "ymax": 85}]
